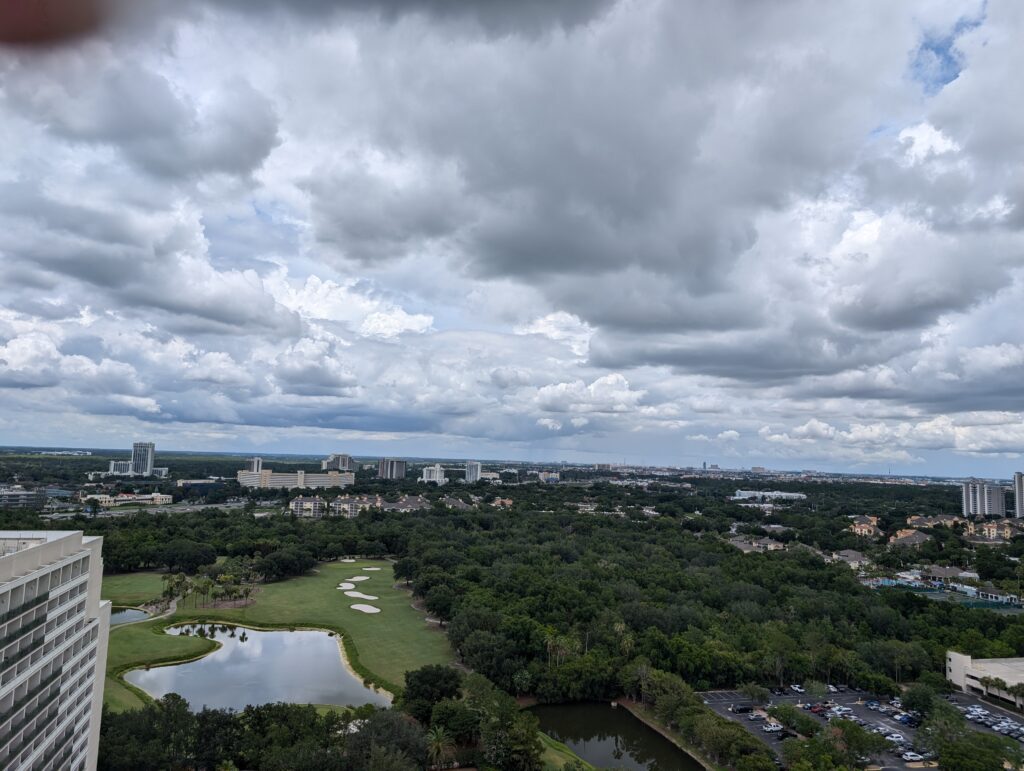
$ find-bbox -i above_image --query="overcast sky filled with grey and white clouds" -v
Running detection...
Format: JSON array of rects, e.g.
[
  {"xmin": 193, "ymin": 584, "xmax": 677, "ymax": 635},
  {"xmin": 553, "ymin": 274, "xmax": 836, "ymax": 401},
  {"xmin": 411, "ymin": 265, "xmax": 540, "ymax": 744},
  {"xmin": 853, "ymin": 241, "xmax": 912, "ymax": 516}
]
[{"xmin": 0, "ymin": 0, "xmax": 1024, "ymax": 476}]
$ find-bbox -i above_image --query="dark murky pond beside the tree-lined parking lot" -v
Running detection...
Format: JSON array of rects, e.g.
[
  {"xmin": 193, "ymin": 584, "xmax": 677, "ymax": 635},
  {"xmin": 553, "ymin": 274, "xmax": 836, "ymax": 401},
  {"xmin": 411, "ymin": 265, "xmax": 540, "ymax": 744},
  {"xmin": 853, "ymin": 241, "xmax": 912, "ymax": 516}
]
[{"xmin": 532, "ymin": 703, "xmax": 702, "ymax": 771}]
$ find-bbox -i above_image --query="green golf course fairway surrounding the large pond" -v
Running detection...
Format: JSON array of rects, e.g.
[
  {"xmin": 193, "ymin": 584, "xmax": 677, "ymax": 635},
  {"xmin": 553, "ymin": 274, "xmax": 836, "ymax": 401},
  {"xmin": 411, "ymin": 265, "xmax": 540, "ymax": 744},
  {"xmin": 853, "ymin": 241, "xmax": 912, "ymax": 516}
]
[{"xmin": 104, "ymin": 560, "xmax": 454, "ymax": 709}]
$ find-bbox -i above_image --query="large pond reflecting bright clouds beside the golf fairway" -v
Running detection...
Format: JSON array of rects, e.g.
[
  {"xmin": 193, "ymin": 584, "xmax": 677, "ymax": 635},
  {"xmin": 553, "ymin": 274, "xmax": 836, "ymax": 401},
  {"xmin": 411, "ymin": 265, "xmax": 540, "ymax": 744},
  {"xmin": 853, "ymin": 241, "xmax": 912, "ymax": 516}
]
[{"xmin": 125, "ymin": 624, "xmax": 390, "ymax": 710}]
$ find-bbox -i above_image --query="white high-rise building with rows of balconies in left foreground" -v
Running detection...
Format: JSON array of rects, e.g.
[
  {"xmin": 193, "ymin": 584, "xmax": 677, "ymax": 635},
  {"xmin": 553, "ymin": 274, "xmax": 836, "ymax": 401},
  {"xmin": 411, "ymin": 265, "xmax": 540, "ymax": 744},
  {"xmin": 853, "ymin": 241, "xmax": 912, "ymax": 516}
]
[{"xmin": 0, "ymin": 530, "xmax": 111, "ymax": 771}]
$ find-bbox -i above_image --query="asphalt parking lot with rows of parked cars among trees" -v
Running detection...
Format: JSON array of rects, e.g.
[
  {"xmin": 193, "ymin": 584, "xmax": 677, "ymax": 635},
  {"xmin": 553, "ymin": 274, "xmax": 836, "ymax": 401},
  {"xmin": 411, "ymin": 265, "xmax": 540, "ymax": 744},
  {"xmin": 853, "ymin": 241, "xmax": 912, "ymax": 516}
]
[{"xmin": 700, "ymin": 691, "xmax": 1024, "ymax": 769}]
